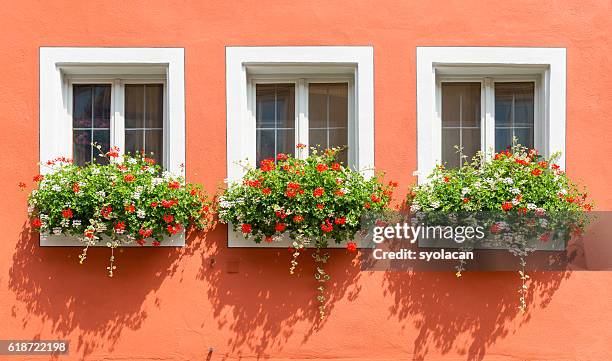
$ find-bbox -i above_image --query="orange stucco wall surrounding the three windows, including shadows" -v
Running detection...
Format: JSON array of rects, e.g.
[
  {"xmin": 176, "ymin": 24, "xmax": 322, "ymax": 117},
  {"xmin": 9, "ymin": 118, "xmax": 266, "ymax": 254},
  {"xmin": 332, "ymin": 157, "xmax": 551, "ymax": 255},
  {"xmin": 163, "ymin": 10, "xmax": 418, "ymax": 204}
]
[{"xmin": 0, "ymin": 0, "xmax": 612, "ymax": 361}]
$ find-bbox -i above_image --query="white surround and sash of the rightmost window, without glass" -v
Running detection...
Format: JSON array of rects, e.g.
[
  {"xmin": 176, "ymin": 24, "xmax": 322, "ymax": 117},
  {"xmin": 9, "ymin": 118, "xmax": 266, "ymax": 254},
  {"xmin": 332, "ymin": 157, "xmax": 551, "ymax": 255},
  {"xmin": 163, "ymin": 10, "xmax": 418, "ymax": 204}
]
[{"xmin": 416, "ymin": 47, "xmax": 566, "ymax": 183}]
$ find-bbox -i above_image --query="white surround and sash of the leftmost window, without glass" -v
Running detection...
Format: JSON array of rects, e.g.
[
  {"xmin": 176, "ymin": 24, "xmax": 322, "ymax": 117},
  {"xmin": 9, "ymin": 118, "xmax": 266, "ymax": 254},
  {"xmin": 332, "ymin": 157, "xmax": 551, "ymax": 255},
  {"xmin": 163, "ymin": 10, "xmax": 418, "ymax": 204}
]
[{"xmin": 40, "ymin": 47, "xmax": 185, "ymax": 174}]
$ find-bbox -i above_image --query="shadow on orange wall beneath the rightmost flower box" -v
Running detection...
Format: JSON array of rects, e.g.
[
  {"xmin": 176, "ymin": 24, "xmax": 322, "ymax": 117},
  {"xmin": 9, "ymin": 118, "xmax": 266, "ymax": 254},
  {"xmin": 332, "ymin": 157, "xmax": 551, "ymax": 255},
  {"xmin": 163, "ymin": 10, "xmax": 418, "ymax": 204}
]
[{"xmin": 384, "ymin": 272, "xmax": 569, "ymax": 361}]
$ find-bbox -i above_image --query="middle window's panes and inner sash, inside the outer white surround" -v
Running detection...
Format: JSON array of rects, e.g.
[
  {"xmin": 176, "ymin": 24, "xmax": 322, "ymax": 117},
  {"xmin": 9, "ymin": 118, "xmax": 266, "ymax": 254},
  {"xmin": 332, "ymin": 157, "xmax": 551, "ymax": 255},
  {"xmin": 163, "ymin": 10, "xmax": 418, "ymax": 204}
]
[{"xmin": 251, "ymin": 77, "xmax": 354, "ymax": 164}]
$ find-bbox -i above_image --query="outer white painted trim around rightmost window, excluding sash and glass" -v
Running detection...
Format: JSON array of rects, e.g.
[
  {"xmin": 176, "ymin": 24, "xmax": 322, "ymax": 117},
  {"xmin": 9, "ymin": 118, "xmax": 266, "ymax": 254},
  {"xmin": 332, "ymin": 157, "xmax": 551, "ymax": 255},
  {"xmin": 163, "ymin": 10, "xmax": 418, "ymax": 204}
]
[{"xmin": 416, "ymin": 47, "xmax": 566, "ymax": 183}]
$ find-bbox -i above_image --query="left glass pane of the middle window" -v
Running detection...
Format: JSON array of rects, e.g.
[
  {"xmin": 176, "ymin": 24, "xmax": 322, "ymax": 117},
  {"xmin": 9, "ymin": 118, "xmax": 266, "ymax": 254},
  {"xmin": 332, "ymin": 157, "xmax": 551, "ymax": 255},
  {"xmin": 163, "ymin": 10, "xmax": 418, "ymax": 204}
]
[{"xmin": 255, "ymin": 83, "xmax": 295, "ymax": 166}]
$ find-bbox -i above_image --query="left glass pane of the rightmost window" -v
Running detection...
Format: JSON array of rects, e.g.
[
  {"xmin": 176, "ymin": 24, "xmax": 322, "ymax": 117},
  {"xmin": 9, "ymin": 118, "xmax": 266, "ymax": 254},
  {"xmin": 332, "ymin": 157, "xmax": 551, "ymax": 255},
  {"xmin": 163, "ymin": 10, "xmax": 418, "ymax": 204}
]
[{"xmin": 441, "ymin": 82, "xmax": 481, "ymax": 168}]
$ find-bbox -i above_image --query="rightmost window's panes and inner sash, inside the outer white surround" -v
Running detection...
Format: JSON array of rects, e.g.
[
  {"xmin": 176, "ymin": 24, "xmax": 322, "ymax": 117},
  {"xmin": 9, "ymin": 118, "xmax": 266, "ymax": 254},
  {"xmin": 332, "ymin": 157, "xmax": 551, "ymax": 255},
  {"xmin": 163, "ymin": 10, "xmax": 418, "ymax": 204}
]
[{"xmin": 438, "ymin": 76, "xmax": 544, "ymax": 168}]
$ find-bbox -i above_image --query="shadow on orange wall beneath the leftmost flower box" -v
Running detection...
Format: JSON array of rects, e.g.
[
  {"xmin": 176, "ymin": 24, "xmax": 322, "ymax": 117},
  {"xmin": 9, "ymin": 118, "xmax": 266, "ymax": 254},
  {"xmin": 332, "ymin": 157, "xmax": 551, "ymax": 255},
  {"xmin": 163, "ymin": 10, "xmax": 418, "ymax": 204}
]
[{"xmin": 9, "ymin": 224, "xmax": 203, "ymax": 358}]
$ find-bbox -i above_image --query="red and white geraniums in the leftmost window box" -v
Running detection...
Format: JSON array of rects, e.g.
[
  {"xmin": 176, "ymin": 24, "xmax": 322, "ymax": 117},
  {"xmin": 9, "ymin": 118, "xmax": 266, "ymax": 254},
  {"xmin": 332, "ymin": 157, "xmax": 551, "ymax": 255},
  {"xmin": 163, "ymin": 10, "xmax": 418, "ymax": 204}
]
[{"xmin": 28, "ymin": 145, "xmax": 211, "ymax": 277}]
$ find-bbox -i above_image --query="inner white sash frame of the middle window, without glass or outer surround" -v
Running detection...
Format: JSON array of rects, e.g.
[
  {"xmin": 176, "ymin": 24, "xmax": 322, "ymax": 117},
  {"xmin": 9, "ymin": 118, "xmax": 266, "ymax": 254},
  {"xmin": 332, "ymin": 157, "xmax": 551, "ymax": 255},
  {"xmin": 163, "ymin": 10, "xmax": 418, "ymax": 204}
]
[{"xmin": 247, "ymin": 74, "xmax": 359, "ymax": 165}]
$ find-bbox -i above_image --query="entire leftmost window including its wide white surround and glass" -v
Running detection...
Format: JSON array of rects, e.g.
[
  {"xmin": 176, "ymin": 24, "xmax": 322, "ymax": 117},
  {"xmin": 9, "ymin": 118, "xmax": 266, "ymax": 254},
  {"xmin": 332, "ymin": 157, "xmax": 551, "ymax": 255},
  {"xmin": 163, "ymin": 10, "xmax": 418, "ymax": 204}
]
[{"xmin": 40, "ymin": 47, "xmax": 185, "ymax": 173}]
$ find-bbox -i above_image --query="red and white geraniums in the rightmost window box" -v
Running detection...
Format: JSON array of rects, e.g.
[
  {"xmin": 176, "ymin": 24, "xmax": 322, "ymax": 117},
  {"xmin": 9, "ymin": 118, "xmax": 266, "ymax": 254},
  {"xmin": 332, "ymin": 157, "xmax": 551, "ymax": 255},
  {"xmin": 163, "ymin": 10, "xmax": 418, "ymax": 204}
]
[{"xmin": 407, "ymin": 145, "xmax": 593, "ymax": 312}]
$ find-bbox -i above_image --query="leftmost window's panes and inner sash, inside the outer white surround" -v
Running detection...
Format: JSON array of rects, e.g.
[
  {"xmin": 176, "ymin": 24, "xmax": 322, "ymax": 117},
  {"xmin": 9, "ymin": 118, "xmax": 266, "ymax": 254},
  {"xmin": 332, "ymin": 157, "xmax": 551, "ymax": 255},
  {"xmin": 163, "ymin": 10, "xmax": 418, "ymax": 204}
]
[{"xmin": 70, "ymin": 78, "xmax": 165, "ymax": 165}]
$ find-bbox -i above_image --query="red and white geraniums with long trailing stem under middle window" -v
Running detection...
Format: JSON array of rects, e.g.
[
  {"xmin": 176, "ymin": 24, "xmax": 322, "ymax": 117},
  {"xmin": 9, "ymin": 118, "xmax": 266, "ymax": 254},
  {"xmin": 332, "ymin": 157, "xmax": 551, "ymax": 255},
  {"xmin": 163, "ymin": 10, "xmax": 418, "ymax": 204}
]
[{"xmin": 219, "ymin": 145, "xmax": 397, "ymax": 317}]
